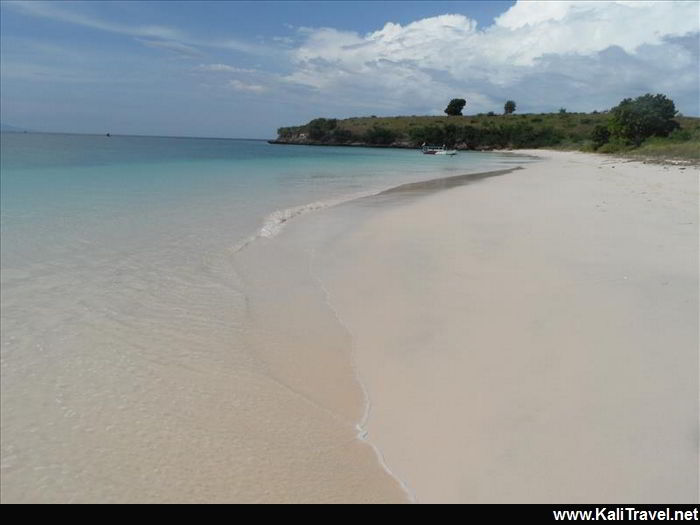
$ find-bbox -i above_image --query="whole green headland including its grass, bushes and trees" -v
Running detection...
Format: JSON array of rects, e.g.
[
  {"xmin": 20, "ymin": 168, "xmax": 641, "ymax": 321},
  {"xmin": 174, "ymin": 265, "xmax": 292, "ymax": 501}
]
[{"xmin": 278, "ymin": 95, "xmax": 700, "ymax": 160}]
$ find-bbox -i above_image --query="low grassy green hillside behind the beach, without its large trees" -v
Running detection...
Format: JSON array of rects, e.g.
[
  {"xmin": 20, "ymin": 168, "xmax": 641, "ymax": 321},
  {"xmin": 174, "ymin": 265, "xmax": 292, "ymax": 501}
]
[{"xmin": 278, "ymin": 112, "xmax": 700, "ymax": 160}]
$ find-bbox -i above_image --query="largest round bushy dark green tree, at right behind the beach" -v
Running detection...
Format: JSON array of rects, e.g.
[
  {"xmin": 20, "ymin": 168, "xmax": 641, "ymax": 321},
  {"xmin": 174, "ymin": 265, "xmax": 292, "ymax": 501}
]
[{"xmin": 609, "ymin": 93, "xmax": 679, "ymax": 146}]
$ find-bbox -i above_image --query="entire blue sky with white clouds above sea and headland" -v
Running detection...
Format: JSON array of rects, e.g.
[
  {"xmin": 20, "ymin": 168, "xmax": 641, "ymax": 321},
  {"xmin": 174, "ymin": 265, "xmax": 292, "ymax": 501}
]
[{"xmin": 0, "ymin": 0, "xmax": 700, "ymax": 138}]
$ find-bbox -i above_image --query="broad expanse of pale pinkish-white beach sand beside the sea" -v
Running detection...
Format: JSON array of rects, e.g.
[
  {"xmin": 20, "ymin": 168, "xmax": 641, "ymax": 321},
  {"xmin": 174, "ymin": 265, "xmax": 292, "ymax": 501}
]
[{"xmin": 314, "ymin": 151, "xmax": 698, "ymax": 503}]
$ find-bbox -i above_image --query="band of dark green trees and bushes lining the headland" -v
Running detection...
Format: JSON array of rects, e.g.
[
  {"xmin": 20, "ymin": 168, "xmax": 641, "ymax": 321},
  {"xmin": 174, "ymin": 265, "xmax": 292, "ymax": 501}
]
[{"xmin": 278, "ymin": 94, "xmax": 680, "ymax": 152}]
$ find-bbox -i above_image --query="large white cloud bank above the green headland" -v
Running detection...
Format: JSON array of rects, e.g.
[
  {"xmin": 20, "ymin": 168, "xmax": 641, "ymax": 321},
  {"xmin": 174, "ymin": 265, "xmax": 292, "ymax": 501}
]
[{"xmin": 285, "ymin": 1, "xmax": 700, "ymax": 114}]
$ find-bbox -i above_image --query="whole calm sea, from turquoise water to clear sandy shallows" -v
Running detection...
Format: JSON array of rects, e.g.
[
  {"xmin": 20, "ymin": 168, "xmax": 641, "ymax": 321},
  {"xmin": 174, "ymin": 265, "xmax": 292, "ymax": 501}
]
[{"xmin": 0, "ymin": 133, "xmax": 526, "ymax": 503}]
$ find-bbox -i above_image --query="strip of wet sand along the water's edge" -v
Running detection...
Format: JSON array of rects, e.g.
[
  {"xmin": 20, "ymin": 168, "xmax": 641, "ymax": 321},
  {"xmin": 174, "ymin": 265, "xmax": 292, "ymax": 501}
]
[{"xmin": 227, "ymin": 159, "xmax": 540, "ymax": 503}]
